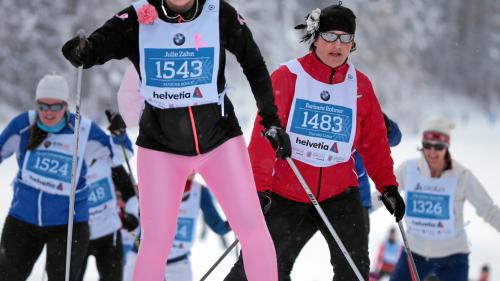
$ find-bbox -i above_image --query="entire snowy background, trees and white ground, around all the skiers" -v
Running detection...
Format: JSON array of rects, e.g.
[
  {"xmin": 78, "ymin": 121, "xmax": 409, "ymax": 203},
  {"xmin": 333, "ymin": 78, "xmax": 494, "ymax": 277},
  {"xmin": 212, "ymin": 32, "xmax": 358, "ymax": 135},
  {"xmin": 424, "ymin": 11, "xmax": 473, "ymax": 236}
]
[{"xmin": 0, "ymin": 0, "xmax": 500, "ymax": 281}]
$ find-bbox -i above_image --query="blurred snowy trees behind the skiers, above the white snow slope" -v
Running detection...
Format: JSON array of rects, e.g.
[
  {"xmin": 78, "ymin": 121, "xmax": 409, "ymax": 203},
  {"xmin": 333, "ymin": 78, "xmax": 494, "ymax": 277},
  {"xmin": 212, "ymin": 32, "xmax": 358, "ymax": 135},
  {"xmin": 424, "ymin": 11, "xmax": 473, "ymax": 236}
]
[{"xmin": 0, "ymin": 0, "xmax": 500, "ymax": 124}]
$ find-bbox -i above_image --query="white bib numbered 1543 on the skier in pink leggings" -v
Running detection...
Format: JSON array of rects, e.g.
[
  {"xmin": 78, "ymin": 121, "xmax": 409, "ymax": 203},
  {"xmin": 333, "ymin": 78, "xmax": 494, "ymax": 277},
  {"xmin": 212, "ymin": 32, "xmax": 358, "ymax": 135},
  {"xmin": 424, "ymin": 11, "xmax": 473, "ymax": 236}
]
[{"xmin": 133, "ymin": 0, "xmax": 220, "ymax": 109}]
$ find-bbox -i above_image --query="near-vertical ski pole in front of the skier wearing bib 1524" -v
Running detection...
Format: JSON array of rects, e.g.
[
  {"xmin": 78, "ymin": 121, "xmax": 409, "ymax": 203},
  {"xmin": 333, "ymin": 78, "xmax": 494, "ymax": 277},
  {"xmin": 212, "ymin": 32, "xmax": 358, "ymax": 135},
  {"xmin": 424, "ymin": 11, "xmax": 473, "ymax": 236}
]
[{"xmin": 64, "ymin": 29, "xmax": 85, "ymax": 281}]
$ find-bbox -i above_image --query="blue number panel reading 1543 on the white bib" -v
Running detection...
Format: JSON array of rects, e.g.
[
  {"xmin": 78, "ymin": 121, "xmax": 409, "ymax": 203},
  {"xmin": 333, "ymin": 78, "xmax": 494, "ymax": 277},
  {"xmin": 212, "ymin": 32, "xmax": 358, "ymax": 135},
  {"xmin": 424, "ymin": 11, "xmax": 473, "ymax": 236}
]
[{"xmin": 144, "ymin": 48, "xmax": 214, "ymax": 88}]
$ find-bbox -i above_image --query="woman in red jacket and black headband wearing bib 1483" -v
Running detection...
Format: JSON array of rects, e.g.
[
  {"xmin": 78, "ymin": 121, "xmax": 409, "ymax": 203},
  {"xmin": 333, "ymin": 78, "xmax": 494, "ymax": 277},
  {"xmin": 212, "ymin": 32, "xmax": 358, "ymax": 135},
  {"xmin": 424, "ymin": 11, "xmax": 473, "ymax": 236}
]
[{"xmin": 225, "ymin": 2, "xmax": 405, "ymax": 281}]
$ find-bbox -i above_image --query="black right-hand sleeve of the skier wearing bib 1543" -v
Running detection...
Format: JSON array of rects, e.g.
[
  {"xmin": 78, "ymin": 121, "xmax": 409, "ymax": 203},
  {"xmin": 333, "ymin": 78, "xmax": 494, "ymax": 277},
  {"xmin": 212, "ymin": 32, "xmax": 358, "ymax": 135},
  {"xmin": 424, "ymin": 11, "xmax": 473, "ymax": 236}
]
[{"xmin": 219, "ymin": 1, "xmax": 280, "ymax": 128}]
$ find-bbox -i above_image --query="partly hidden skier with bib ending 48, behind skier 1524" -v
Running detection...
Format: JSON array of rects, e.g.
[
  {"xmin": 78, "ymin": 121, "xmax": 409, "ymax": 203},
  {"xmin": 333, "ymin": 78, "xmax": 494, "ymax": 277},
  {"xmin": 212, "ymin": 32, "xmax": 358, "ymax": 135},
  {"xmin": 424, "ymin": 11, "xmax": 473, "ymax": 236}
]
[{"xmin": 78, "ymin": 110, "xmax": 139, "ymax": 281}]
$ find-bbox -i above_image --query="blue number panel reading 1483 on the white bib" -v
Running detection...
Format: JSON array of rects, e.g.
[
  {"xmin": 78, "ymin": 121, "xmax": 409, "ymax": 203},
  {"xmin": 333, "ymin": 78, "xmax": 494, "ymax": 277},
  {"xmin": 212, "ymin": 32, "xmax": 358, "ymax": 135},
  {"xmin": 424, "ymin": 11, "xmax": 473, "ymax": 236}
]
[{"xmin": 290, "ymin": 99, "xmax": 352, "ymax": 143}]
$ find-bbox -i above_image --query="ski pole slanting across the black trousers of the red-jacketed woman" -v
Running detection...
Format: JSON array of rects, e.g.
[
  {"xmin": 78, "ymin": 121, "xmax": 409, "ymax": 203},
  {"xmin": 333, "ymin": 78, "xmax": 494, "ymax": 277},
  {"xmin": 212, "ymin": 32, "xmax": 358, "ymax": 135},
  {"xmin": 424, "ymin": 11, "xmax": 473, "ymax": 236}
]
[{"xmin": 286, "ymin": 157, "xmax": 364, "ymax": 281}]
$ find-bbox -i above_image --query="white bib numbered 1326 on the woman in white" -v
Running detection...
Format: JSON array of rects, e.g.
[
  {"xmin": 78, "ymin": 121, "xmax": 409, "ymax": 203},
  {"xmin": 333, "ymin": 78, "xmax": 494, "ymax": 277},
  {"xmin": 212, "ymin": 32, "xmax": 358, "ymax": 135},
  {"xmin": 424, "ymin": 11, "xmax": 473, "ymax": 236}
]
[{"xmin": 405, "ymin": 161, "xmax": 458, "ymax": 240}]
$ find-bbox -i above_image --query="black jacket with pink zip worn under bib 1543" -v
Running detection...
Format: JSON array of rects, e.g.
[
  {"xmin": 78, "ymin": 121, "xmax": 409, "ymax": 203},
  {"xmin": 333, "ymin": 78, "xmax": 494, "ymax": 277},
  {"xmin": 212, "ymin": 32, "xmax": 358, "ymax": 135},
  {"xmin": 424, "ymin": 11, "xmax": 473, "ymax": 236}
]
[{"xmin": 62, "ymin": 0, "xmax": 281, "ymax": 156}]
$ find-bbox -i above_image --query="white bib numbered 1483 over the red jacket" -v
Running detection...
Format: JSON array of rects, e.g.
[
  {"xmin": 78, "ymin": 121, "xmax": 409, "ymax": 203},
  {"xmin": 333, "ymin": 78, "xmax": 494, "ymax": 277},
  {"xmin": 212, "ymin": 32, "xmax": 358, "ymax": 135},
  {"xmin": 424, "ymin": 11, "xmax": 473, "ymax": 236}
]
[{"xmin": 286, "ymin": 60, "xmax": 357, "ymax": 167}]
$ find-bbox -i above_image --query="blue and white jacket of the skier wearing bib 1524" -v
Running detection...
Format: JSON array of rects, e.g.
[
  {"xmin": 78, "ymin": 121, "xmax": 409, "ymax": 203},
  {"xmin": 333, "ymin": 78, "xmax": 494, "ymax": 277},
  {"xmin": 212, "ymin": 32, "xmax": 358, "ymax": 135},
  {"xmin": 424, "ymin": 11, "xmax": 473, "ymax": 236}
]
[{"xmin": 0, "ymin": 111, "xmax": 131, "ymax": 227}]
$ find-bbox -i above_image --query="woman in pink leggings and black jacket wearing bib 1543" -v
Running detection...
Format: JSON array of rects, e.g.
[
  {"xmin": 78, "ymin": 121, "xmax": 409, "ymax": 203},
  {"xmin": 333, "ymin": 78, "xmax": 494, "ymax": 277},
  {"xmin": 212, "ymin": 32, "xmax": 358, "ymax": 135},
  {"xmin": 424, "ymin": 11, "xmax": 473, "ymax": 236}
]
[{"xmin": 62, "ymin": 0, "xmax": 291, "ymax": 281}]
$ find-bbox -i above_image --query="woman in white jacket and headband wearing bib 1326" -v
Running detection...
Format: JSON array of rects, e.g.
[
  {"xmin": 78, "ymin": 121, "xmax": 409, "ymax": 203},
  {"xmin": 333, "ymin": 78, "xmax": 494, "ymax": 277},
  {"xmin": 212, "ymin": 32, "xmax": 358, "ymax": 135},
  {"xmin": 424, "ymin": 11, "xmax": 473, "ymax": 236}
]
[{"xmin": 390, "ymin": 120, "xmax": 500, "ymax": 281}]
